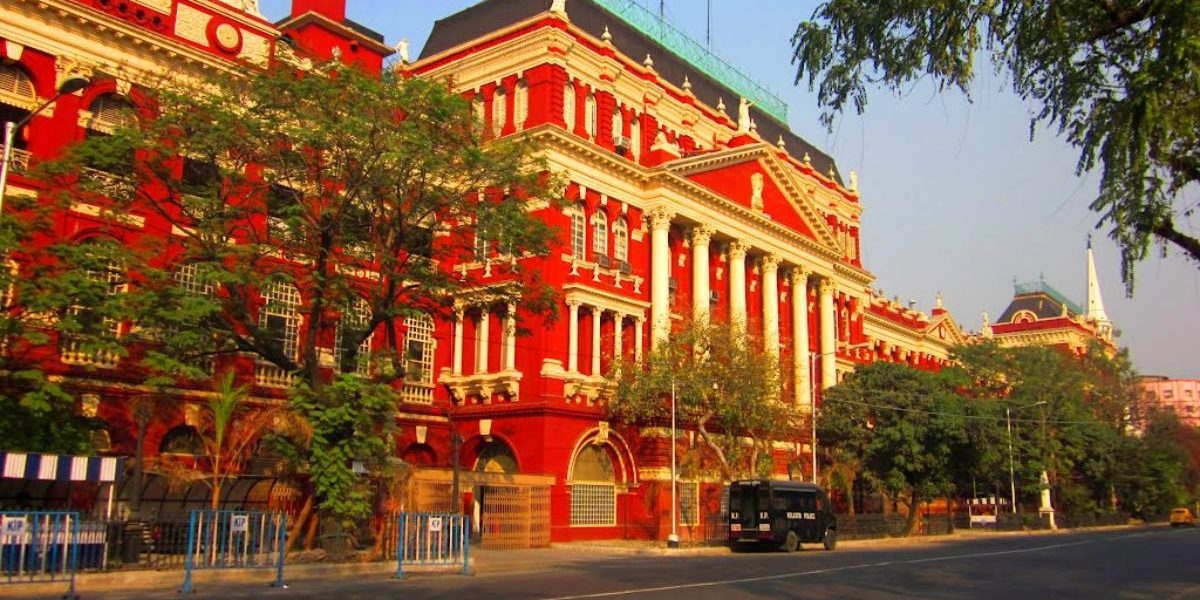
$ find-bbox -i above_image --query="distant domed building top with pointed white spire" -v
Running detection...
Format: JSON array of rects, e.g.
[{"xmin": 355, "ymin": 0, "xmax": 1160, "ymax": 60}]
[{"xmin": 980, "ymin": 240, "xmax": 1116, "ymax": 354}]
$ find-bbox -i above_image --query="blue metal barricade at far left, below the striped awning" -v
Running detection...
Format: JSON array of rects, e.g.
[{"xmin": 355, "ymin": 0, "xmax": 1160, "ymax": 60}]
[{"xmin": 0, "ymin": 511, "xmax": 79, "ymax": 598}]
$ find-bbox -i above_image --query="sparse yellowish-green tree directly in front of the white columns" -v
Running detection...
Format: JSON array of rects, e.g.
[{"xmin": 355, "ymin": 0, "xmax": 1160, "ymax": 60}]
[{"xmin": 608, "ymin": 322, "xmax": 802, "ymax": 480}]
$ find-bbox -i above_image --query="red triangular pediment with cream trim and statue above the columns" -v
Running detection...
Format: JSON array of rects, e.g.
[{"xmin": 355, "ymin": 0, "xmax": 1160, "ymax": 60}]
[{"xmin": 665, "ymin": 144, "xmax": 841, "ymax": 254}]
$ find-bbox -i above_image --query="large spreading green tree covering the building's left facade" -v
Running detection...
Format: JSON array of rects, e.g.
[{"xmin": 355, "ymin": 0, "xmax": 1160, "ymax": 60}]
[{"xmin": 25, "ymin": 58, "xmax": 557, "ymax": 523}]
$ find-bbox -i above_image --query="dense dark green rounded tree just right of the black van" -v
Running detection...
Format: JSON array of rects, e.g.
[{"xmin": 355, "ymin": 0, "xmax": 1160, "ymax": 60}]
[{"xmin": 817, "ymin": 362, "xmax": 968, "ymax": 534}]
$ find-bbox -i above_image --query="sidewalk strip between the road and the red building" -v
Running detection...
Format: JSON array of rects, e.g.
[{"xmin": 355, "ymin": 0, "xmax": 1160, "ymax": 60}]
[{"xmin": 0, "ymin": 524, "xmax": 1154, "ymax": 596}]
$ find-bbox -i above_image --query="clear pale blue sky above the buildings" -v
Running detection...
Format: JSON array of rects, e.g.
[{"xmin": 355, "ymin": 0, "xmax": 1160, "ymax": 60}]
[{"xmin": 260, "ymin": 0, "xmax": 1200, "ymax": 378}]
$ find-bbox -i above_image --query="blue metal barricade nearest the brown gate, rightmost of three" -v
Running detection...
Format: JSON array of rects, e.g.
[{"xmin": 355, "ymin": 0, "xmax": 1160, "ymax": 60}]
[{"xmin": 396, "ymin": 512, "xmax": 470, "ymax": 580}]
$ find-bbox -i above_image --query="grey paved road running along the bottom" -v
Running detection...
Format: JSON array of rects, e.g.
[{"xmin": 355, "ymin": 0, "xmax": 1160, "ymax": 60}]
[{"xmin": 11, "ymin": 527, "xmax": 1200, "ymax": 600}]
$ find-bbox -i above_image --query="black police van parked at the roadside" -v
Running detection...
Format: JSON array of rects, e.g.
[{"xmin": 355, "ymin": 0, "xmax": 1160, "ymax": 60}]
[{"xmin": 728, "ymin": 479, "xmax": 838, "ymax": 552}]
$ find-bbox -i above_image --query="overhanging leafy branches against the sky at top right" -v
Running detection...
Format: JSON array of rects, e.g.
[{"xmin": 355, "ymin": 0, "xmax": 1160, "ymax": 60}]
[{"xmin": 792, "ymin": 0, "xmax": 1200, "ymax": 293}]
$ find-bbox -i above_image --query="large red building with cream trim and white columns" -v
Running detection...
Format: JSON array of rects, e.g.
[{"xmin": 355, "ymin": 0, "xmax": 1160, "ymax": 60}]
[{"xmin": 0, "ymin": 0, "xmax": 964, "ymax": 545}]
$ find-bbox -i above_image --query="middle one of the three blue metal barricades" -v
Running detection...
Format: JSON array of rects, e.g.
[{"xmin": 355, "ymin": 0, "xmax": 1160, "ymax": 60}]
[{"xmin": 181, "ymin": 510, "xmax": 288, "ymax": 593}]
